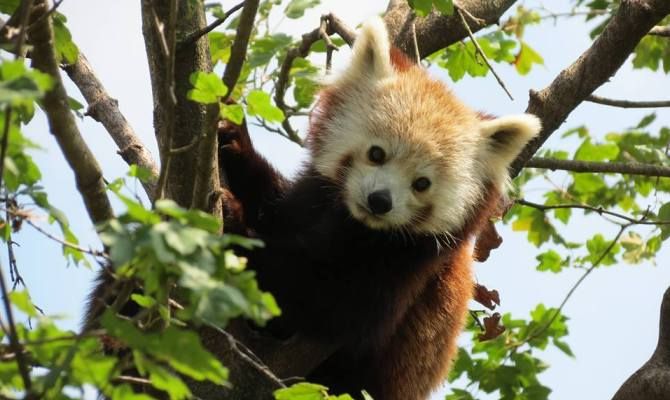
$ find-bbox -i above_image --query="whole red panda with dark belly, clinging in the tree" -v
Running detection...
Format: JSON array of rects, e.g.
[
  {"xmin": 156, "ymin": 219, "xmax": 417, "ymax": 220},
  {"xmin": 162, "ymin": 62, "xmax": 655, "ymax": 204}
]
[{"xmin": 220, "ymin": 19, "xmax": 540, "ymax": 400}]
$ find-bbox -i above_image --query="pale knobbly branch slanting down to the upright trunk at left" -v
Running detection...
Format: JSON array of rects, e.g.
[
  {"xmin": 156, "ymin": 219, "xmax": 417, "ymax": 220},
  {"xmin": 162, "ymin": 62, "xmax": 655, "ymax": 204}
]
[{"xmin": 64, "ymin": 52, "xmax": 158, "ymax": 199}]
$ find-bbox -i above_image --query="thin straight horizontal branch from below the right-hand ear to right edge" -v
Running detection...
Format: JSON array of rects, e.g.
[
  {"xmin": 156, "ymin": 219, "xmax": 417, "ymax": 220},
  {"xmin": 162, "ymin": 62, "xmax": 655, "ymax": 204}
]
[{"xmin": 525, "ymin": 157, "xmax": 670, "ymax": 177}]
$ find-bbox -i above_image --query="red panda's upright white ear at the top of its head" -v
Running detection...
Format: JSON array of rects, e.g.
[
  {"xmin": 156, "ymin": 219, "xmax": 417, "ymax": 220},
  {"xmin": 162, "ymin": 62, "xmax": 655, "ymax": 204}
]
[{"xmin": 337, "ymin": 17, "xmax": 393, "ymax": 83}]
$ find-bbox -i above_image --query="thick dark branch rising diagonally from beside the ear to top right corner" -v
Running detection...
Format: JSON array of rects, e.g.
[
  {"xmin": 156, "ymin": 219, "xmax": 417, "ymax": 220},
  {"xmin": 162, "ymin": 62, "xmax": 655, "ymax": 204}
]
[{"xmin": 511, "ymin": 0, "xmax": 670, "ymax": 177}]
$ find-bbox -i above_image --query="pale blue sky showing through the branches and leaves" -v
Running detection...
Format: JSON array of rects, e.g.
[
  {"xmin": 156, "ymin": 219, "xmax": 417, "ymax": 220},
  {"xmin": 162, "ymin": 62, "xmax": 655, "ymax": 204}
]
[{"xmin": 6, "ymin": 0, "xmax": 670, "ymax": 399}]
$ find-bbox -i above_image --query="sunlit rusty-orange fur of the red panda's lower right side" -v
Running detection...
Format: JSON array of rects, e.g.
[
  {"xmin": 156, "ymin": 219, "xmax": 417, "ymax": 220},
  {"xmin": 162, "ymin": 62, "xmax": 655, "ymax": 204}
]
[{"xmin": 372, "ymin": 244, "xmax": 473, "ymax": 400}]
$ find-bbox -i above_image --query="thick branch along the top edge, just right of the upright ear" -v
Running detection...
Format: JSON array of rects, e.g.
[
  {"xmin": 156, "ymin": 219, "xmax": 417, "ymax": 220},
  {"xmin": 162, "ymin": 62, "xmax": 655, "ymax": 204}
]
[{"xmin": 384, "ymin": 0, "xmax": 516, "ymax": 58}]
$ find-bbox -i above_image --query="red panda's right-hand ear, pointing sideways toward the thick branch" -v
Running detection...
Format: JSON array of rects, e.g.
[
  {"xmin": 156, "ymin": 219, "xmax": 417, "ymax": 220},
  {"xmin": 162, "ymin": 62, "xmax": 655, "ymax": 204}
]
[{"xmin": 480, "ymin": 114, "xmax": 542, "ymax": 184}]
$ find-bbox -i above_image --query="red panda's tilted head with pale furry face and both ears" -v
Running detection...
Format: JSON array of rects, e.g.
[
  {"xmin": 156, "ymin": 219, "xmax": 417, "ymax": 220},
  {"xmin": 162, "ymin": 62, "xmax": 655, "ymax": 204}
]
[{"xmin": 309, "ymin": 19, "xmax": 540, "ymax": 235}]
